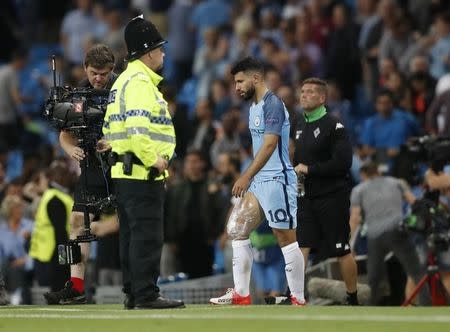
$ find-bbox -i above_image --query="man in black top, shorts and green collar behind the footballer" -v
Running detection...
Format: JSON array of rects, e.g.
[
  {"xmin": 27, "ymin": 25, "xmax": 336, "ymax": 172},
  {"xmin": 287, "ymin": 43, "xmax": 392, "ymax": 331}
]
[{"xmin": 294, "ymin": 78, "xmax": 358, "ymax": 305}]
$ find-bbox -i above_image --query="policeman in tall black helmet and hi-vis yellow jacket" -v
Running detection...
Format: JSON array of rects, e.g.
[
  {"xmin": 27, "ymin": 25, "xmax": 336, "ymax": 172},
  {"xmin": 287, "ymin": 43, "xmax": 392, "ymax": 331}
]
[{"xmin": 103, "ymin": 17, "xmax": 184, "ymax": 309}]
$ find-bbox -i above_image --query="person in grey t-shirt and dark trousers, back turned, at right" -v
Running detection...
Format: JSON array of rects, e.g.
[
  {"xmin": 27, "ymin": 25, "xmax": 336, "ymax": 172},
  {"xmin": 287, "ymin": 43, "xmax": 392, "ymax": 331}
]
[{"xmin": 350, "ymin": 162, "xmax": 430, "ymax": 305}]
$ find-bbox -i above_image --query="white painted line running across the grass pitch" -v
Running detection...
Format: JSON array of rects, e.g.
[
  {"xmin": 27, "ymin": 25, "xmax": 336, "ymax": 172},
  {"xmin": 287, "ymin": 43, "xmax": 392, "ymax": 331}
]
[{"xmin": 0, "ymin": 312, "xmax": 450, "ymax": 324}]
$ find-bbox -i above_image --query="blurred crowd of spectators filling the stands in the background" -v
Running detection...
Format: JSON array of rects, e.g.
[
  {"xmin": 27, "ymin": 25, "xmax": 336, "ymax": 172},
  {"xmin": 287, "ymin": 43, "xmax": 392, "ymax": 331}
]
[{"xmin": 0, "ymin": 0, "xmax": 450, "ymax": 302}]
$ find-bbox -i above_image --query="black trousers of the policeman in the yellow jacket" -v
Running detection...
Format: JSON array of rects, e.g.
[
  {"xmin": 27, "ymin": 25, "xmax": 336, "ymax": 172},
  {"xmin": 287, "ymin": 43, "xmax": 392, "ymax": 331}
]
[{"xmin": 114, "ymin": 179, "xmax": 165, "ymax": 304}]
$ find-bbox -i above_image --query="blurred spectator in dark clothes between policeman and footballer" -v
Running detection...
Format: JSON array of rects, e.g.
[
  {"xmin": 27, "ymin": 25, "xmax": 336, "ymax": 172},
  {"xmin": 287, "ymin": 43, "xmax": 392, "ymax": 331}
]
[{"xmin": 164, "ymin": 151, "xmax": 226, "ymax": 278}]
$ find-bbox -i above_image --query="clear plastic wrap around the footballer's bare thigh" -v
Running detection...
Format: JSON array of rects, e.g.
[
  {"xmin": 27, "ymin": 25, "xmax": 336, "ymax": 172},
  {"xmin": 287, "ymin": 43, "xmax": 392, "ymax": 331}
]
[{"xmin": 227, "ymin": 199, "xmax": 261, "ymax": 240}]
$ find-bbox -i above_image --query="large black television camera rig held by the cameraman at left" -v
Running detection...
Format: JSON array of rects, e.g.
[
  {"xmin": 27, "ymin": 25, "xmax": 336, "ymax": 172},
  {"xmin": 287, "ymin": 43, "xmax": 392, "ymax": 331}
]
[{"xmin": 44, "ymin": 56, "xmax": 115, "ymax": 265}]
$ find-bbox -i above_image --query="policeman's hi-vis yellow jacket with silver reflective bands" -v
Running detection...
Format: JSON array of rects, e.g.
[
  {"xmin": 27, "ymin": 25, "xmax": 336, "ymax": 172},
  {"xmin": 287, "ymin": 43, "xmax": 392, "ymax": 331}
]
[{"xmin": 103, "ymin": 60, "xmax": 175, "ymax": 180}]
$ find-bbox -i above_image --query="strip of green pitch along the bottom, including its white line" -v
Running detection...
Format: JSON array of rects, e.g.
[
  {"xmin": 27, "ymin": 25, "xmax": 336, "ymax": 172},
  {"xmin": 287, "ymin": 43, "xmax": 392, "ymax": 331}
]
[{"xmin": 0, "ymin": 305, "xmax": 450, "ymax": 332}]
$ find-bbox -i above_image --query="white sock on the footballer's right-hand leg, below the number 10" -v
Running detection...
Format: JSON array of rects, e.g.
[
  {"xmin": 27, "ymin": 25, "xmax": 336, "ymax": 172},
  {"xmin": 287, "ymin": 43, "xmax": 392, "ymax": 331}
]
[{"xmin": 281, "ymin": 242, "xmax": 305, "ymax": 301}]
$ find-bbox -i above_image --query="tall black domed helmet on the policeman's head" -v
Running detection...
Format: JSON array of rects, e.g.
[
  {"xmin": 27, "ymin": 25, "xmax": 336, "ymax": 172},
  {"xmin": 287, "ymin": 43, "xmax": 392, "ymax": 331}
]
[{"xmin": 125, "ymin": 15, "xmax": 167, "ymax": 61}]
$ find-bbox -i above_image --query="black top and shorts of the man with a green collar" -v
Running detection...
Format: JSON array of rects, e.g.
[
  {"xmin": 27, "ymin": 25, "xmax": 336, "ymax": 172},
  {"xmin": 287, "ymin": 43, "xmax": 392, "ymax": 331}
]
[{"xmin": 294, "ymin": 107, "xmax": 352, "ymax": 258}]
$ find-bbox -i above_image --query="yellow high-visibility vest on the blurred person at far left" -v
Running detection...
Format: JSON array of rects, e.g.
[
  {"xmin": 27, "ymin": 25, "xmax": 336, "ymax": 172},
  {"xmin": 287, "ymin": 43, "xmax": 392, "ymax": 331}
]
[{"xmin": 30, "ymin": 188, "xmax": 73, "ymax": 263}]
